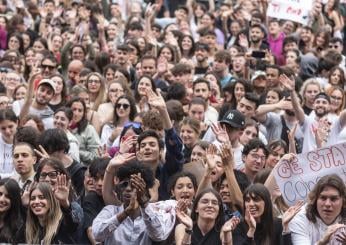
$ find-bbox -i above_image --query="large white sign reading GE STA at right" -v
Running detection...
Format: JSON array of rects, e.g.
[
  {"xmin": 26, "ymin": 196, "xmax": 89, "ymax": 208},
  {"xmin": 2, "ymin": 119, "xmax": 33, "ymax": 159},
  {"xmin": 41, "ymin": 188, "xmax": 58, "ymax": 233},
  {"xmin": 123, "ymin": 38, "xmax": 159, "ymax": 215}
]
[{"xmin": 274, "ymin": 143, "xmax": 346, "ymax": 205}]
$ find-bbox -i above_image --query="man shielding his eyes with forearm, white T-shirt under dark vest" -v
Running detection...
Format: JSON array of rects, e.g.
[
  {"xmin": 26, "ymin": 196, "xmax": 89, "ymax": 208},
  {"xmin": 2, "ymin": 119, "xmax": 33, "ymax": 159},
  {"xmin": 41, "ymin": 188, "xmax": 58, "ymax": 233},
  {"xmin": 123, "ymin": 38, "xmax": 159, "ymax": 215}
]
[{"xmin": 256, "ymin": 91, "xmax": 303, "ymax": 153}]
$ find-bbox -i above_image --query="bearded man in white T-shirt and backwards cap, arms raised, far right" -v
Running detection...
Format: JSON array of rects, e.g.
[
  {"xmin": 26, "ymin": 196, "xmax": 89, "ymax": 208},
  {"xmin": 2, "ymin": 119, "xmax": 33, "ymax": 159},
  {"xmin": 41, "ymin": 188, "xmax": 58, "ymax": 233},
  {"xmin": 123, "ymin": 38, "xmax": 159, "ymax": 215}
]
[{"xmin": 280, "ymin": 75, "xmax": 346, "ymax": 153}]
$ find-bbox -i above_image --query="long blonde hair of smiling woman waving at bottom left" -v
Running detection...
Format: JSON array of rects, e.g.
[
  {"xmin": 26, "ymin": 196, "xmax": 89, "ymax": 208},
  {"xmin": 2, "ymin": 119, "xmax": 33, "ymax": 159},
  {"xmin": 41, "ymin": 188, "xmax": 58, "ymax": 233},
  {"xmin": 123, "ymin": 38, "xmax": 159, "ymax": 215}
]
[{"xmin": 25, "ymin": 183, "xmax": 63, "ymax": 244}]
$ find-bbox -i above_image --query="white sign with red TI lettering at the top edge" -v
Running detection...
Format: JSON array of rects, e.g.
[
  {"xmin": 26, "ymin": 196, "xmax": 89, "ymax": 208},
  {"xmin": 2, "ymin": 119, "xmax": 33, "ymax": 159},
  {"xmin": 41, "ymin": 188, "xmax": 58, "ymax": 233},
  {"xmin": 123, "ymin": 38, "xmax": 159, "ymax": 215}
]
[{"xmin": 267, "ymin": 0, "xmax": 313, "ymax": 25}]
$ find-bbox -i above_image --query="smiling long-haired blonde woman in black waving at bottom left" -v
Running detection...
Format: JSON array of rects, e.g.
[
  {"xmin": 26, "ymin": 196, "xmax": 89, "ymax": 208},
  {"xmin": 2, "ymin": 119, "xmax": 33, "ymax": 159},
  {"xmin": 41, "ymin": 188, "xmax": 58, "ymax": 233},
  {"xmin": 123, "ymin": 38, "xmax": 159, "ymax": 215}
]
[{"xmin": 25, "ymin": 181, "xmax": 78, "ymax": 244}]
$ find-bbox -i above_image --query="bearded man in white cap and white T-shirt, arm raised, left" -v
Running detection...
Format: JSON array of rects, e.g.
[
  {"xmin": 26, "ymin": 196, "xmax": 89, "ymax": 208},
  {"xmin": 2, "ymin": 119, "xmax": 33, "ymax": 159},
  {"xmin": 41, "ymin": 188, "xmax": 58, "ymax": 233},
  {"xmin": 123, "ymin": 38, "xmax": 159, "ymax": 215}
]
[{"xmin": 13, "ymin": 74, "xmax": 55, "ymax": 129}]
